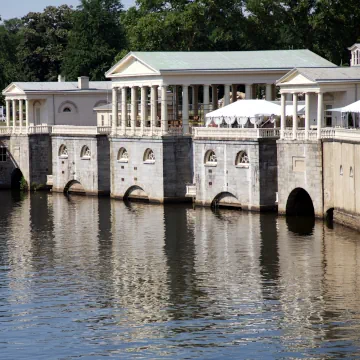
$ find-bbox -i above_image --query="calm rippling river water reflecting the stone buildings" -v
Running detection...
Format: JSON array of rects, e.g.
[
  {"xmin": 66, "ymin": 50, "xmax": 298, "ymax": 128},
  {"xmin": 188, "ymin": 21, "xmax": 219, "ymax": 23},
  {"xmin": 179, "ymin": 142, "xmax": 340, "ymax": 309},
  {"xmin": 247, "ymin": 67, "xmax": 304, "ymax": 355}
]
[{"xmin": 0, "ymin": 191, "xmax": 360, "ymax": 359}]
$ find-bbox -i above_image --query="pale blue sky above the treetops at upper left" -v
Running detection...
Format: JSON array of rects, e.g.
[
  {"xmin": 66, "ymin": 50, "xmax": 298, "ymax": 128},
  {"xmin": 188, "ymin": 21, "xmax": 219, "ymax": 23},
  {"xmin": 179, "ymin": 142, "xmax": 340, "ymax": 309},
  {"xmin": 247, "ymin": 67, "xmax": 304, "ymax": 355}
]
[{"xmin": 0, "ymin": 0, "xmax": 135, "ymax": 20}]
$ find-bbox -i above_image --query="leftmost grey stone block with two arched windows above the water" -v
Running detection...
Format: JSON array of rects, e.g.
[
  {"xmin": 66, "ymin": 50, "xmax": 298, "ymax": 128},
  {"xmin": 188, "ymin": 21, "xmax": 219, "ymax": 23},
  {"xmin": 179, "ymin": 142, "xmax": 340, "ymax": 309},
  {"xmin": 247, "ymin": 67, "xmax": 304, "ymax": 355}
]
[{"xmin": 52, "ymin": 135, "xmax": 110, "ymax": 195}]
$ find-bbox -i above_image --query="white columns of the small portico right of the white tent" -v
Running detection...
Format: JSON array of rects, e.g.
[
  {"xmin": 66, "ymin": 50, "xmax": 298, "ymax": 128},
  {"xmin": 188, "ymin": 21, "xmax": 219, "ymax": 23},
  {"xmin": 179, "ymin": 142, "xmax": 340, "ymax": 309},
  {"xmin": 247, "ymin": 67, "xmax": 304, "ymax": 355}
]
[{"xmin": 280, "ymin": 92, "xmax": 324, "ymax": 140}]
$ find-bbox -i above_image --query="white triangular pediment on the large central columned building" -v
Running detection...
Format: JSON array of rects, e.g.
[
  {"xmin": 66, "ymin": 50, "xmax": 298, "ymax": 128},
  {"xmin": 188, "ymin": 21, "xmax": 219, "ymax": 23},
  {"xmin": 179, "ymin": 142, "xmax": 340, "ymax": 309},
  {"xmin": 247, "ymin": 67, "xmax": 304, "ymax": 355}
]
[{"xmin": 106, "ymin": 53, "xmax": 158, "ymax": 78}]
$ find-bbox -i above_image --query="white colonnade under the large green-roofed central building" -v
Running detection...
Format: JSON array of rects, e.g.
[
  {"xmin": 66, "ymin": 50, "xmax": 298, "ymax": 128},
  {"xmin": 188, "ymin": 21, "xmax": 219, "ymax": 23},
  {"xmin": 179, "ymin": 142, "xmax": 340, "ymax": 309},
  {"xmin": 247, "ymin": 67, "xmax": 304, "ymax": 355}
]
[{"xmin": 111, "ymin": 84, "xmax": 274, "ymax": 136}]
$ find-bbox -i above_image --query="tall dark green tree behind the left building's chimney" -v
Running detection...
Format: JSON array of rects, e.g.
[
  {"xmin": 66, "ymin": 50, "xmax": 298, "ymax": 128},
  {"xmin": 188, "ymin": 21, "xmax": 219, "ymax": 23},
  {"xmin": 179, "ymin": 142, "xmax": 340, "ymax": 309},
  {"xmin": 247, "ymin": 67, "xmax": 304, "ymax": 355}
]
[{"xmin": 62, "ymin": 0, "xmax": 126, "ymax": 80}]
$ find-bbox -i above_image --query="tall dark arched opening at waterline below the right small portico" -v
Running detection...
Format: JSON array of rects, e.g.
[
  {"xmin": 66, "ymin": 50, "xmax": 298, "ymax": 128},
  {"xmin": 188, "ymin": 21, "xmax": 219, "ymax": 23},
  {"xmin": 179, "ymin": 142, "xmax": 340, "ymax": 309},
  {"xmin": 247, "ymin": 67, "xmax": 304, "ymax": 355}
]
[{"xmin": 286, "ymin": 188, "xmax": 315, "ymax": 217}]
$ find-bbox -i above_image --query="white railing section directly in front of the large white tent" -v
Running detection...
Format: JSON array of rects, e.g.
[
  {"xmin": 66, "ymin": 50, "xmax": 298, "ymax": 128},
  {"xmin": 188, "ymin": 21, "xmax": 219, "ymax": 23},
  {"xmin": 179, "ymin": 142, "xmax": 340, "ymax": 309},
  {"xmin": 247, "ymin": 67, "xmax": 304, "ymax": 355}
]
[{"xmin": 192, "ymin": 127, "xmax": 280, "ymax": 140}]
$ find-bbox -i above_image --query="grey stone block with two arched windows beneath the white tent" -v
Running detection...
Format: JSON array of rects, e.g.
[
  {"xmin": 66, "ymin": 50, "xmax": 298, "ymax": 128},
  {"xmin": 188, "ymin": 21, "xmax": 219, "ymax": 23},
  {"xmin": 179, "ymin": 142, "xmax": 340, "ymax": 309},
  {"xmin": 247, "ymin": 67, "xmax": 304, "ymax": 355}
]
[{"xmin": 194, "ymin": 139, "xmax": 277, "ymax": 211}]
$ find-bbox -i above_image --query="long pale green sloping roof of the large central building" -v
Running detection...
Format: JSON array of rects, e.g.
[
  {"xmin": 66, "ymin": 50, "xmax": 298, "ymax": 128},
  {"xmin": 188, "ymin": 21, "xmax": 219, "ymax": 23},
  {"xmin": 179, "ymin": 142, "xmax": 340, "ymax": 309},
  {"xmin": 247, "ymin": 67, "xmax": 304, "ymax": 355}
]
[{"xmin": 131, "ymin": 49, "xmax": 336, "ymax": 72}]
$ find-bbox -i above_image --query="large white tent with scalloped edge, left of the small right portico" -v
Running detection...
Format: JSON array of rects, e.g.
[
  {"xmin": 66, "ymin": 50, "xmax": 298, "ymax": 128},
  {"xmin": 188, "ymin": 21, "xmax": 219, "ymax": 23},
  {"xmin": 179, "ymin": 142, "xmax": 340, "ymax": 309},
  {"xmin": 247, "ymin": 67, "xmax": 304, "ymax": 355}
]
[{"xmin": 206, "ymin": 100, "xmax": 281, "ymax": 126}]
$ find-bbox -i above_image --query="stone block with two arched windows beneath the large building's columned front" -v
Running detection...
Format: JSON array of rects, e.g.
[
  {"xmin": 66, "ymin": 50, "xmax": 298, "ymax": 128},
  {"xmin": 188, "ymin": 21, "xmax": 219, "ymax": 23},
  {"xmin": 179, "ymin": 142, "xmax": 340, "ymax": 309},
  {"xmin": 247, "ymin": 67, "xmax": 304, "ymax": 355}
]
[{"xmin": 110, "ymin": 136, "xmax": 193, "ymax": 203}]
